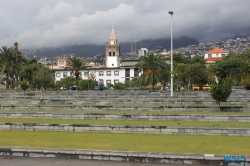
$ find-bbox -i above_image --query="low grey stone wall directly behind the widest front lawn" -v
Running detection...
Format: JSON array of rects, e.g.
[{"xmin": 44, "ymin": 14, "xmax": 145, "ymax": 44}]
[{"xmin": 0, "ymin": 123, "xmax": 250, "ymax": 136}]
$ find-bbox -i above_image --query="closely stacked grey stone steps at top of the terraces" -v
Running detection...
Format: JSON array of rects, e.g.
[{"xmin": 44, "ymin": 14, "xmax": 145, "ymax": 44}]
[{"xmin": 0, "ymin": 90, "xmax": 250, "ymax": 105}]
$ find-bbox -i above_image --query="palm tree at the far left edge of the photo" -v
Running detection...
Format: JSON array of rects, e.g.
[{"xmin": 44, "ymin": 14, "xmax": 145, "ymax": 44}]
[{"xmin": 0, "ymin": 46, "xmax": 19, "ymax": 89}]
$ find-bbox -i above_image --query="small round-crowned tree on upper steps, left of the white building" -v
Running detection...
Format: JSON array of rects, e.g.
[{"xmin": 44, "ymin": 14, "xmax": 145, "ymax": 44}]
[{"xmin": 32, "ymin": 68, "xmax": 54, "ymax": 104}]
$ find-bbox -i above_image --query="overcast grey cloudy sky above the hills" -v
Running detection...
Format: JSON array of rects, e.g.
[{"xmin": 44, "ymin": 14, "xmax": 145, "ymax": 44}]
[{"xmin": 0, "ymin": 0, "xmax": 250, "ymax": 49}]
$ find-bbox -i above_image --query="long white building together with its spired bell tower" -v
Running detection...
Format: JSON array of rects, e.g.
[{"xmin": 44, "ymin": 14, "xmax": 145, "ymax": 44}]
[{"xmin": 53, "ymin": 28, "xmax": 138, "ymax": 85}]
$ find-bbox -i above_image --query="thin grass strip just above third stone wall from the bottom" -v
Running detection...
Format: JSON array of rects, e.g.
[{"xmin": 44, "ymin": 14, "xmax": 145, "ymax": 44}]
[{"xmin": 0, "ymin": 109, "xmax": 250, "ymax": 116}]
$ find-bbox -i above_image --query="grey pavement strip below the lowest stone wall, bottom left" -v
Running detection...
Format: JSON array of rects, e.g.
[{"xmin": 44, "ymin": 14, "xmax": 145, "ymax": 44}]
[{"xmin": 0, "ymin": 156, "xmax": 207, "ymax": 166}]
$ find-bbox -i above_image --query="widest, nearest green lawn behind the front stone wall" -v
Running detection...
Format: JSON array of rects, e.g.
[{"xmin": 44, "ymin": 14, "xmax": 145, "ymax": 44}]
[{"xmin": 0, "ymin": 131, "xmax": 250, "ymax": 155}]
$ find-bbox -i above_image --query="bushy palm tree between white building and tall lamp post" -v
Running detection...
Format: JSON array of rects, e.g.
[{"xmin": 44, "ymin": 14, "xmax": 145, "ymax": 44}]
[{"xmin": 136, "ymin": 52, "xmax": 168, "ymax": 89}]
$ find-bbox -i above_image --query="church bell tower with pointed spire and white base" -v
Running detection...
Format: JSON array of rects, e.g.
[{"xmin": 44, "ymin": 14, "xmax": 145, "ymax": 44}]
[{"xmin": 105, "ymin": 27, "xmax": 120, "ymax": 68}]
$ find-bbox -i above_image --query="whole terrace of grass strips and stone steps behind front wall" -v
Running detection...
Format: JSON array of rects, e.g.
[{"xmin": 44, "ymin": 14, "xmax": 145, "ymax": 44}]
[{"xmin": 0, "ymin": 91, "xmax": 250, "ymax": 155}]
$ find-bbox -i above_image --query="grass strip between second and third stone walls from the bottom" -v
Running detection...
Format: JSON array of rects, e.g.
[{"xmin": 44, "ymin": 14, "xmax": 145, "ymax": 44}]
[{"xmin": 0, "ymin": 118, "xmax": 250, "ymax": 128}]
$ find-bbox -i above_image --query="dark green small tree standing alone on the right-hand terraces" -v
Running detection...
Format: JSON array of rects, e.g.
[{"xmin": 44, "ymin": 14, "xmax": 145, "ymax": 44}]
[{"xmin": 210, "ymin": 76, "xmax": 232, "ymax": 112}]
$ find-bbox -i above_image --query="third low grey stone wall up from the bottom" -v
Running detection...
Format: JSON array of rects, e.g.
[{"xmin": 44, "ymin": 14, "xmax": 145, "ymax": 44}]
[{"xmin": 0, "ymin": 112, "xmax": 250, "ymax": 122}]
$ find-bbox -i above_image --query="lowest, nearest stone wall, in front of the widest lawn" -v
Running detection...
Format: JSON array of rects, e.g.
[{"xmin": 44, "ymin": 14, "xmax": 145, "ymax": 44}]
[{"xmin": 0, "ymin": 147, "xmax": 250, "ymax": 166}]
